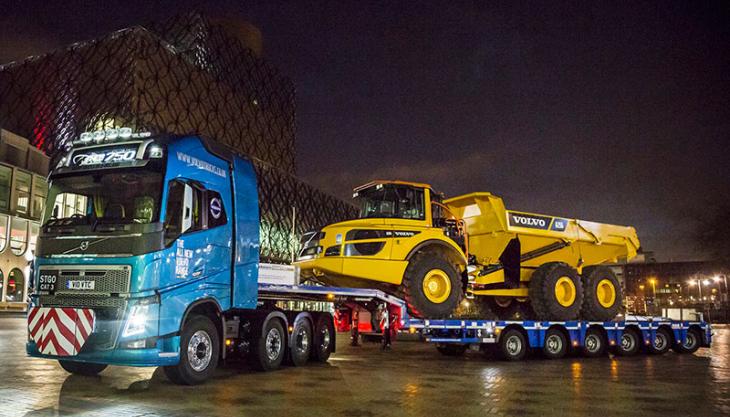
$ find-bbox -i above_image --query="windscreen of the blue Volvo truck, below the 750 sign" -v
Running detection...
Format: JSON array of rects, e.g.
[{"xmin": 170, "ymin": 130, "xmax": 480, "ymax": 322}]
[{"xmin": 43, "ymin": 168, "xmax": 163, "ymax": 227}]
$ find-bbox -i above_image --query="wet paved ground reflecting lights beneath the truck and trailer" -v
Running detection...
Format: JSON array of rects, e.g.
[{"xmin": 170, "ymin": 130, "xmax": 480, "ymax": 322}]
[{"xmin": 0, "ymin": 316, "xmax": 730, "ymax": 417}]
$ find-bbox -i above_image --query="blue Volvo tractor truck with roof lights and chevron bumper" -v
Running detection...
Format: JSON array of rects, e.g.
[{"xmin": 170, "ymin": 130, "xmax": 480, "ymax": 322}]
[{"xmin": 26, "ymin": 128, "xmax": 405, "ymax": 384}]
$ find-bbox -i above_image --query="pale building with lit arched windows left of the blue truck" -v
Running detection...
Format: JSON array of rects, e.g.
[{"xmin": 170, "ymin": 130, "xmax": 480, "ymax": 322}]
[{"xmin": 0, "ymin": 129, "xmax": 49, "ymax": 310}]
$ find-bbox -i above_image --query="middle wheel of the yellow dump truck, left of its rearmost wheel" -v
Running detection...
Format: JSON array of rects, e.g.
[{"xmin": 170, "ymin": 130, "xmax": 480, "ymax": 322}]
[{"xmin": 529, "ymin": 262, "xmax": 583, "ymax": 321}]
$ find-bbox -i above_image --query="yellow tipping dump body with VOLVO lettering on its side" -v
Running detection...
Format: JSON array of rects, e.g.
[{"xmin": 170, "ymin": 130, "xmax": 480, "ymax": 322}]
[{"xmin": 444, "ymin": 192, "xmax": 639, "ymax": 295}]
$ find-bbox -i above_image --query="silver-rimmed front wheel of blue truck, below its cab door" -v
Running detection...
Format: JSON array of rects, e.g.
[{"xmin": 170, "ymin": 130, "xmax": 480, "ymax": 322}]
[{"xmin": 163, "ymin": 315, "xmax": 221, "ymax": 385}]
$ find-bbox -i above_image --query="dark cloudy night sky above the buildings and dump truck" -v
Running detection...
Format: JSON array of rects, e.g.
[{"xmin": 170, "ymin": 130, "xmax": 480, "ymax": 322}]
[{"xmin": 0, "ymin": 0, "xmax": 730, "ymax": 260}]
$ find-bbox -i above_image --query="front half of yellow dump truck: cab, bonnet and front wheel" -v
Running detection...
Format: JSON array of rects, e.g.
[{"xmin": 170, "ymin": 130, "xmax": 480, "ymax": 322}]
[{"xmin": 296, "ymin": 180, "xmax": 466, "ymax": 316}]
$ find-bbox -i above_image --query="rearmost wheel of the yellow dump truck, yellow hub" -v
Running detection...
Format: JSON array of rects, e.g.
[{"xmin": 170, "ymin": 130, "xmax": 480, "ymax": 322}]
[{"xmin": 582, "ymin": 266, "xmax": 623, "ymax": 321}]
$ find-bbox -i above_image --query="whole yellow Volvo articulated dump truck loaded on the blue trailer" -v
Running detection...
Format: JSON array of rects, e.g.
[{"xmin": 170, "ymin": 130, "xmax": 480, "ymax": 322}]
[{"xmin": 296, "ymin": 180, "xmax": 639, "ymax": 321}]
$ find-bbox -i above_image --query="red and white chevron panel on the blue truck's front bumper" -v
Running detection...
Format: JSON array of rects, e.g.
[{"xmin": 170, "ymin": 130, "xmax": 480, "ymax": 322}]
[{"xmin": 28, "ymin": 307, "xmax": 96, "ymax": 356}]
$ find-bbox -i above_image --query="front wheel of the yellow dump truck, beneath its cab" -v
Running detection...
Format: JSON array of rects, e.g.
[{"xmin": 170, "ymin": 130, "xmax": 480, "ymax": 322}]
[{"xmin": 403, "ymin": 252, "xmax": 463, "ymax": 318}]
